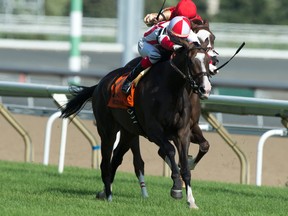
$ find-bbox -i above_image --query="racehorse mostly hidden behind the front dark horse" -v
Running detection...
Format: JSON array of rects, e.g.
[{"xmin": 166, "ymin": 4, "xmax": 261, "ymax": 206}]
[{"xmin": 107, "ymin": 20, "xmax": 218, "ymax": 202}]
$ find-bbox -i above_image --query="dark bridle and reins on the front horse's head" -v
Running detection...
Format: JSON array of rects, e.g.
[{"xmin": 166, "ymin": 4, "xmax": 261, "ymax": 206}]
[{"xmin": 170, "ymin": 46, "xmax": 211, "ymax": 93}]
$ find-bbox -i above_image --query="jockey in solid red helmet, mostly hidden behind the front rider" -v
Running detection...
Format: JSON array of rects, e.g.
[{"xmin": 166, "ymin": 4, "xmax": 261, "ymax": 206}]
[{"xmin": 144, "ymin": 0, "xmax": 219, "ymax": 74}]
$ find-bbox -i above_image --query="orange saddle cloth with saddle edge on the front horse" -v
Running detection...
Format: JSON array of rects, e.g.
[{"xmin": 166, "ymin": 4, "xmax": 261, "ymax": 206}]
[{"xmin": 107, "ymin": 67, "xmax": 150, "ymax": 109}]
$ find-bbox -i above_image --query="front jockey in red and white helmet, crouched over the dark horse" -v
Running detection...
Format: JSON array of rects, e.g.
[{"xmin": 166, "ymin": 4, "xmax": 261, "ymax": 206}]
[{"xmin": 122, "ymin": 16, "xmax": 200, "ymax": 94}]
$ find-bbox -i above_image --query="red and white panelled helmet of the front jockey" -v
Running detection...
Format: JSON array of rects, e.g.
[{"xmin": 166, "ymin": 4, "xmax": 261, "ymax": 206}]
[{"xmin": 167, "ymin": 16, "xmax": 191, "ymax": 38}]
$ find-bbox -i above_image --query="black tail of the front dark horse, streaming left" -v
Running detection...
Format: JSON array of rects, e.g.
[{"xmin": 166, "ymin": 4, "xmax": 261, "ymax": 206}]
[{"xmin": 61, "ymin": 85, "xmax": 97, "ymax": 118}]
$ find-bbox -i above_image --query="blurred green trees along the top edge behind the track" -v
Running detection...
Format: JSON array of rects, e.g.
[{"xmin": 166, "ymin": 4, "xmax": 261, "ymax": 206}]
[{"xmin": 45, "ymin": 0, "xmax": 288, "ymax": 25}]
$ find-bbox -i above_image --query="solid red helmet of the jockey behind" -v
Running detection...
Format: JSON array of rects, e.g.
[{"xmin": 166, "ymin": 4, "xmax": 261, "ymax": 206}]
[{"xmin": 171, "ymin": 0, "xmax": 197, "ymax": 19}]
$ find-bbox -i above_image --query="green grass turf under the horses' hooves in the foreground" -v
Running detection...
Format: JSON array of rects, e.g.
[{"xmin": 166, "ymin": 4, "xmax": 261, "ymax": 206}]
[{"xmin": 0, "ymin": 161, "xmax": 288, "ymax": 216}]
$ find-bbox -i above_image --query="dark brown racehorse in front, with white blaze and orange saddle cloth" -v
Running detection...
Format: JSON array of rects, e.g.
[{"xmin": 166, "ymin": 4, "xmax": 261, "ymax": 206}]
[{"xmin": 61, "ymin": 41, "xmax": 211, "ymax": 208}]
